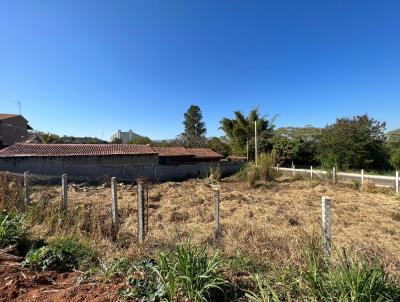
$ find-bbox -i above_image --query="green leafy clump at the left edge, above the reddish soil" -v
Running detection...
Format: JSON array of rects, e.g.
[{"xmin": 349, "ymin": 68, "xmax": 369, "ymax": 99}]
[{"xmin": 0, "ymin": 210, "xmax": 27, "ymax": 248}]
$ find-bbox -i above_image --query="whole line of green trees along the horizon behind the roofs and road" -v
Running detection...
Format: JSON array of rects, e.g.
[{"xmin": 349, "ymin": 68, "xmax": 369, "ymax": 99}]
[{"xmin": 36, "ymin": 105, "xmax": 400, "ymax": 171}]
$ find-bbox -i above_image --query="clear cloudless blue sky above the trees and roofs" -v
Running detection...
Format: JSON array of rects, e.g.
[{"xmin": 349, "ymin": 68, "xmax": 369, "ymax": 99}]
[{"xmin": 0, "ymin": 0, "xmax": 400, "ymax": 139}]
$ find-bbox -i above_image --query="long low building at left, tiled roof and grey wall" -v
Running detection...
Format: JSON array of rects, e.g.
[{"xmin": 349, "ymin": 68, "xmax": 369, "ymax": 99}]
[{"xmin": 0, "ymin": 144, "xmax": 158, "ymax": 178}]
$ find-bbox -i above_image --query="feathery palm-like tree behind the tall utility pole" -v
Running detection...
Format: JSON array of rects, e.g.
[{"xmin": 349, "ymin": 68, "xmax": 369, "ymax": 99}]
[{"xmin": 220, "ymin": 109, "xmax": 276, "ymax": 156}]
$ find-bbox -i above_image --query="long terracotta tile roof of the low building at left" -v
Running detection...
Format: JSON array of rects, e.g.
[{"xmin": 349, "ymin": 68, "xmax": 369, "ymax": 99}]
[{"xmin": 0, "ymin": 144, "xmax": 157, "ymax": 157}]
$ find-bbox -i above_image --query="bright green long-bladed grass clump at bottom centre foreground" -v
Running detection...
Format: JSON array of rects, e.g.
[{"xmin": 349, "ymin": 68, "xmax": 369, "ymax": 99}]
[{"xmin": 155, "ymin": 241, "xmax": 227, "ymax": 301}]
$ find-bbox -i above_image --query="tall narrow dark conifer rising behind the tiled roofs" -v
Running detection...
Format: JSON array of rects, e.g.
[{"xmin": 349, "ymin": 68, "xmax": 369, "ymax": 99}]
[{"xmin": 182, "ymin": 105, "xmax": 206, "ymax": 148}]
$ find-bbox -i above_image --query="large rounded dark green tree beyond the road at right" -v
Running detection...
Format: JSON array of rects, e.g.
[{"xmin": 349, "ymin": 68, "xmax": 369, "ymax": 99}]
[{"xmin": 318, "ymin": 115, "xmax": 388, "ymax": 169}]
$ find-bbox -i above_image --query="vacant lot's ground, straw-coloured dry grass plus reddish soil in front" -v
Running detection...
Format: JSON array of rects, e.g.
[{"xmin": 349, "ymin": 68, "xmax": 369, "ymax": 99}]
[{"xmin": 0, "ymin": 177, "xmax": 400, "ymax": 301}]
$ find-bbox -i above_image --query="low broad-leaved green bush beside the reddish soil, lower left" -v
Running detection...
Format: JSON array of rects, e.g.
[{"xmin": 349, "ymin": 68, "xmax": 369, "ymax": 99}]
[{"xmin": 22, "ymin": 236, "xmax": 97, "ymax": 272}]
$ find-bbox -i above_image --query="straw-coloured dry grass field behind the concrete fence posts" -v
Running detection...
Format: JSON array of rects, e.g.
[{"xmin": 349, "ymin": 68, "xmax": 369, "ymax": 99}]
[{"xmin": 17, "ymin": 178, "xmax": 400, "ymax": 272}]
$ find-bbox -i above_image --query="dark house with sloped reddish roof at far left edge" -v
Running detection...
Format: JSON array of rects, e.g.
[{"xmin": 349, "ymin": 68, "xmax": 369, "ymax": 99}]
[{"xmin": 0, "ymin": 113, "xmax": 32, "ymax": 148}]
